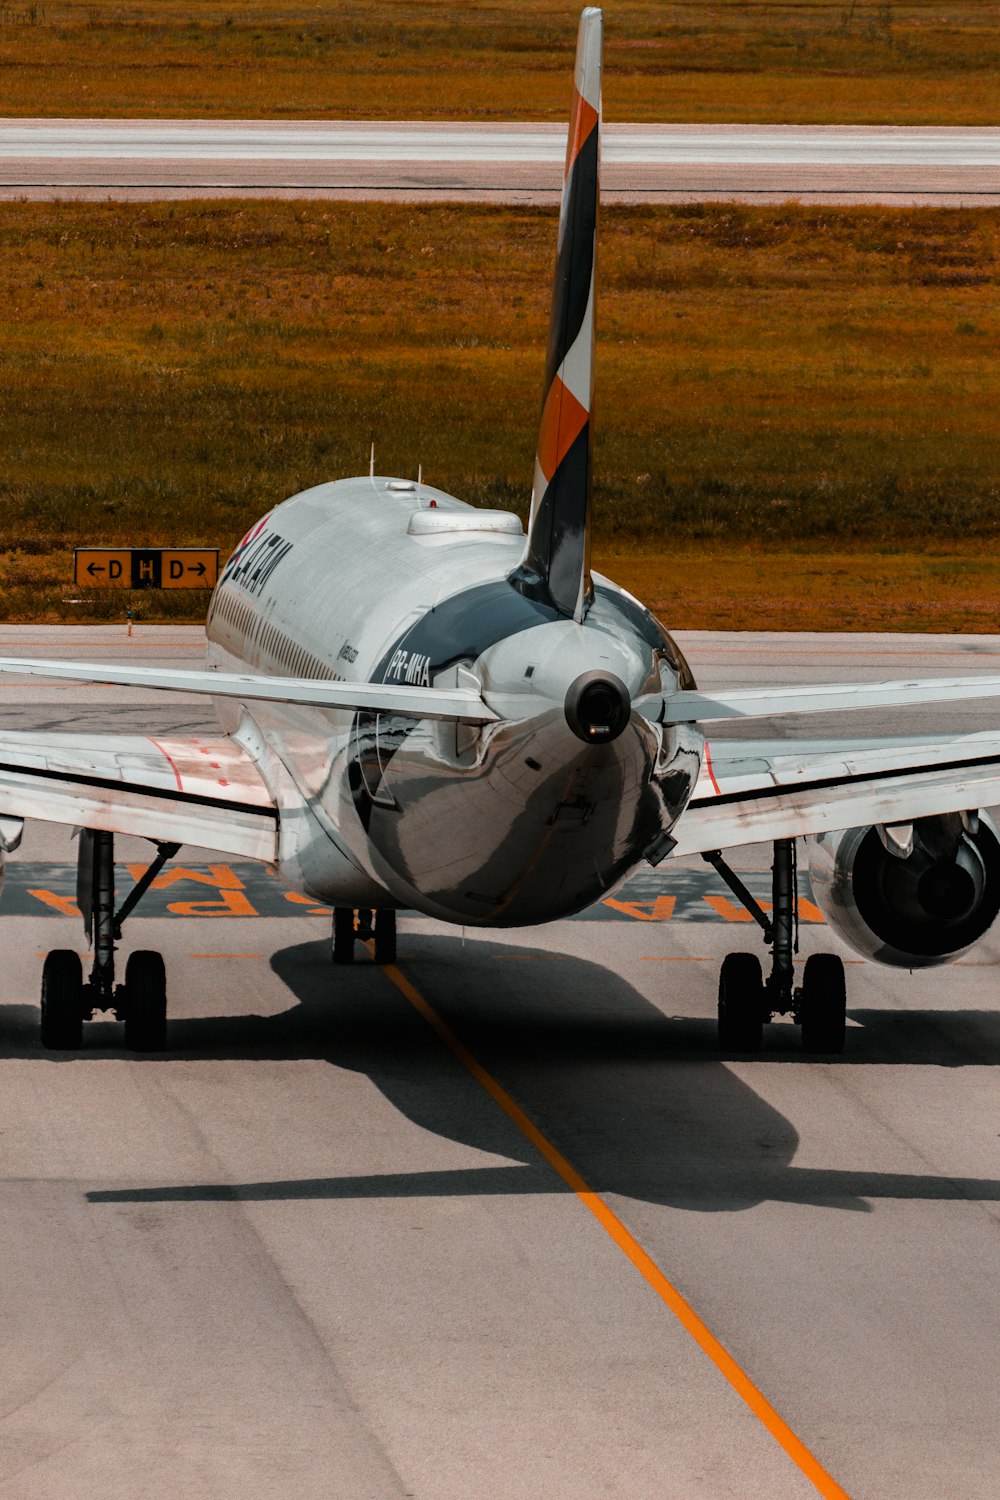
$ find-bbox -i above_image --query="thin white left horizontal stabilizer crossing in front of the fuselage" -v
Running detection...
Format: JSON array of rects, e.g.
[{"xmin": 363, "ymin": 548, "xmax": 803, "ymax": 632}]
[{"xmin": 0, "ymin": 657, "xmax": 499, "ymax": 725}]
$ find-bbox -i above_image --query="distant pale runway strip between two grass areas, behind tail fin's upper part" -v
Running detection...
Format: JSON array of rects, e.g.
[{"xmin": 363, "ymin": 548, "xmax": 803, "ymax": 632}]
[{"xmin": 0, "ymin": 120, "xmax": 1000, "ymax": 206}]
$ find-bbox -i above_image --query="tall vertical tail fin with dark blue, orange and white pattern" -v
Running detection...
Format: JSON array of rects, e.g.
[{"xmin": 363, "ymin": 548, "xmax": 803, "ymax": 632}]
[{"xmin": 511, "ymin": 6, "xmax": 603, "ymax": 621}]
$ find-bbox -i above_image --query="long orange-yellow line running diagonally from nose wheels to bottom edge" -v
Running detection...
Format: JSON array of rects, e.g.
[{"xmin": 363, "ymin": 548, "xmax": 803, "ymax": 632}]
[{"xmin": 382, "ymin": 963, "xmax": 850, "ymax": 1500}]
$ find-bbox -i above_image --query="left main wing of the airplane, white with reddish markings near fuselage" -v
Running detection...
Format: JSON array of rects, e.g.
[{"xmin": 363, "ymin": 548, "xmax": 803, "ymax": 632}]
[{"xmin": 0, "ymin": 732, "xmax": 277, "ymax": 861}]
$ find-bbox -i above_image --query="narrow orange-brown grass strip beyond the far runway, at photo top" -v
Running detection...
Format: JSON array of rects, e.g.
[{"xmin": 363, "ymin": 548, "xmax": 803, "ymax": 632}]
[{"xmin": 0, "ymin": 0, "xmax": 1000, "ymax": 125}]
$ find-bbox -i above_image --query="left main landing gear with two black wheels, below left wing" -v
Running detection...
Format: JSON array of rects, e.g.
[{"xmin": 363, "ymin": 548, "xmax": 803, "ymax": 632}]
[{"xmin": 42, "ymin": 828, "xmax": 180, "ymax": 1052}]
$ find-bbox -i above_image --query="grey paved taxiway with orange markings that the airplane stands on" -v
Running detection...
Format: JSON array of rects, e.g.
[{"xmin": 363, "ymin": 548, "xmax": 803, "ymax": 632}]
[{"xmin": 0, "ymin": 626, "xmax": 1000, "ymax": 1500}]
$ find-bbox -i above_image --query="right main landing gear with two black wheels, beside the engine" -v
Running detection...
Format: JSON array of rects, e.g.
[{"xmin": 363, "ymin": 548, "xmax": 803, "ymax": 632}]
[{"xmin": 703, "ymin": 839, "xmax": 847, "ymax": 1055}]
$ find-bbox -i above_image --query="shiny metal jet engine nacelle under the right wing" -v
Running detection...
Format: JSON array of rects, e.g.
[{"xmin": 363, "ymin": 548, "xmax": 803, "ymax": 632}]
[{"xmin": 805, "ymin": 813, "xmax": 1000, "ymax": 969}]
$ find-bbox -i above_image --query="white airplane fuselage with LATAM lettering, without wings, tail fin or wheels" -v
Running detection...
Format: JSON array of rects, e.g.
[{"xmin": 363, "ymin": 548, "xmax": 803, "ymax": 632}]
[{"xmin": 207, "ymin": 476, "xmax": 702, "ymax": 927}]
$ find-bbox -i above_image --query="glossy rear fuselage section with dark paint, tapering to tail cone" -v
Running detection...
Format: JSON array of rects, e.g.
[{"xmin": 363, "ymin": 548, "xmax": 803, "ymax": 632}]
[{"xmin": 351, "ymin": 582, "xmax": 699, "ymax": 927}]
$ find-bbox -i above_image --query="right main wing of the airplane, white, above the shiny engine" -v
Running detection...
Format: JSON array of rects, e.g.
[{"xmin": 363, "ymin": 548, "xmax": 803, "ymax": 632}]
[{"xmin": 670, "ymin": 735, "xmax": 1000, "ymax": 858}]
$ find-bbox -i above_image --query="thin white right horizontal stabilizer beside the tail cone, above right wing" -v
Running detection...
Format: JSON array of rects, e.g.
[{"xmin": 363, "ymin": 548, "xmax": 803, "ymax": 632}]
[{"xmin": 663, "ymin": 674, "xmax": 1000, "ymax": 725}]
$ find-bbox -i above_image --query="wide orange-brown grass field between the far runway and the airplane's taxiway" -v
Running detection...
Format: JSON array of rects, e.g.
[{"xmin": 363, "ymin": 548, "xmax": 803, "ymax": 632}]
[{"xmin": 0, "ymin": 201, "xmax": 1000, "ymax": 629}]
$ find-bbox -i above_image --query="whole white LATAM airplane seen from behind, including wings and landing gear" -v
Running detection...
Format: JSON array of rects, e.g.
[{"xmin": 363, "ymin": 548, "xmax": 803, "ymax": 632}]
[{"xmin": 0, "ymin": 8, "xmax": 1000, "ymax": 1056}]
